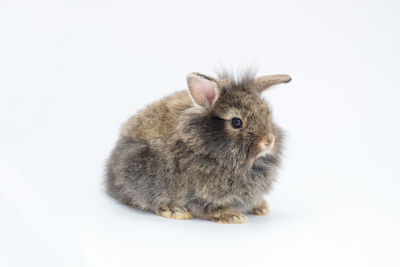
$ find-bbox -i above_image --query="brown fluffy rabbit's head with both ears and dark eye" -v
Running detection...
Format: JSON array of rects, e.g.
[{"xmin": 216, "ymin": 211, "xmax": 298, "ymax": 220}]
[{"xmin": 181, "ymin": 73, "xmax": 291, "ymax": 168}]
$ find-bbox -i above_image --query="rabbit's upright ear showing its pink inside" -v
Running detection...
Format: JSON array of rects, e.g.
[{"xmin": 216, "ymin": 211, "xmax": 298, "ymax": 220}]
[{"xmin": 186, "ymin": 72, "xmax": 219, "ymax": 108}]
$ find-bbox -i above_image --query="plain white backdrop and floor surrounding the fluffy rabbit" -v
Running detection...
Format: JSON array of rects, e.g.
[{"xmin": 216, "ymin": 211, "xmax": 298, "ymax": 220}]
[{"xmin": 0, "ymin": 0, "xmax": 400, "ymax": 267}]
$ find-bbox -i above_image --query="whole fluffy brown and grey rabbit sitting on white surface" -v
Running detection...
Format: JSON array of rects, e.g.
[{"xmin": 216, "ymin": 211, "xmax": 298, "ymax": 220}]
[{"xmin": 106, "ymin": 69, "xmax": 291, "ymax": 224}]
